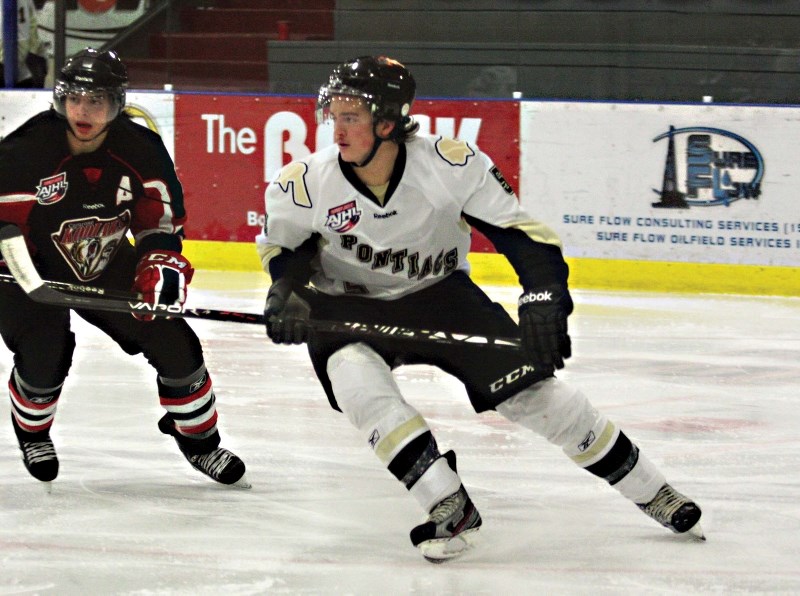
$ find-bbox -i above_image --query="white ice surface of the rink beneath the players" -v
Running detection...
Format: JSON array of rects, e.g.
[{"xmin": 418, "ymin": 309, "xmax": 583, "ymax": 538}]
[{"xmin": 0, "ymin": 271, "xmax": 800, "ymax": 596}]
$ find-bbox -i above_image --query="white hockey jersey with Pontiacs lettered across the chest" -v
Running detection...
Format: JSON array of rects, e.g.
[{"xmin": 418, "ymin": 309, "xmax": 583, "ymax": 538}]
[{"xmin": 256, "ymin": 136, "xmax": 560, "ymax": 300}]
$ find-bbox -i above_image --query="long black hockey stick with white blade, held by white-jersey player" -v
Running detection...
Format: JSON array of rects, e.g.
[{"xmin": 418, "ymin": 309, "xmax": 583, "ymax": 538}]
[{"xmin": 0, "ymin": 225, "xmax": 520, "ymax": 351}]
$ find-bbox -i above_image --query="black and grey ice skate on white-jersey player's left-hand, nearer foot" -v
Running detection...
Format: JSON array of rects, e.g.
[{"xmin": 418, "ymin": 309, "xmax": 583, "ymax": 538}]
[{"xmin": 411, "ymin": 451, "xmax": 483, "ymax": 563}]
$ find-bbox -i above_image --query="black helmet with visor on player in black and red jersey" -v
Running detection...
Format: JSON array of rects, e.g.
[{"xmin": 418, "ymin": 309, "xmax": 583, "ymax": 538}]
[{"xmin": 53, "ymin": 48, "xmax": 128, "ymax": 120}]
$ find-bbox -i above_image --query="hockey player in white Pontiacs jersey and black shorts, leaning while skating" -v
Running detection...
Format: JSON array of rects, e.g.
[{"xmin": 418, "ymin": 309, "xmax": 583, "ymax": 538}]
[{"xmin": 257, "ymin": 56, "xmax": 703, "ymax": 562}]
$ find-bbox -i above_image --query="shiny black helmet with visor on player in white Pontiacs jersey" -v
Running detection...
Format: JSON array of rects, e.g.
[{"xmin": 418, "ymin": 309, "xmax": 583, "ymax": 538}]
[{"xmin": 317, "ymin": 56, "xmax": 417, "ymax": 133}]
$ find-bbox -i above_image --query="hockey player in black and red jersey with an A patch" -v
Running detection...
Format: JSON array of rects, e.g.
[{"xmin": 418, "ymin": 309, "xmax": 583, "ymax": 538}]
[{"xmin": 0, "ymin": 48, "xmax": 247, "ymax": 486}]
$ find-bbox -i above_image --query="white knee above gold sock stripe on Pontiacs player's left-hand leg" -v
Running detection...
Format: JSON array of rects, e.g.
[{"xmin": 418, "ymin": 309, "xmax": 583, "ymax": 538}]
[{"xmin": 327, "ymin": 343, "xmax": 405, "ymax": 429}]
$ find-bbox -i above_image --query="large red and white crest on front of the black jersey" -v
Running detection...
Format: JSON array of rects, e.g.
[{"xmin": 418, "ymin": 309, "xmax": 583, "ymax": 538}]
[{"xmin": 51, "ymin": 211, "xmax": 131, "ymax": 281}]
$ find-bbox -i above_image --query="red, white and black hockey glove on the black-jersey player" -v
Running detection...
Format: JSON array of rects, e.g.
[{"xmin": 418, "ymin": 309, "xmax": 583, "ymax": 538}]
[{"xmin": 133, "ymin": 250, "xmax": 194, "ymax": 321}]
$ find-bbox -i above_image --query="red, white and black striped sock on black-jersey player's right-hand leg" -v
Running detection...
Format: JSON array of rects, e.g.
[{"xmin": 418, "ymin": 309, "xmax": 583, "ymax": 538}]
[{"xmin": 158, "ymin": 366, "xmax": 220, "ymax": 454}]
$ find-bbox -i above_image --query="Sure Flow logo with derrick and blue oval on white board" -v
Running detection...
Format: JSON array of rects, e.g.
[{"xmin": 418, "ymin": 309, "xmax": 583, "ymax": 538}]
[{"xmin": 652, "ymin": 126, "xmax": 764, "ymax": 209}]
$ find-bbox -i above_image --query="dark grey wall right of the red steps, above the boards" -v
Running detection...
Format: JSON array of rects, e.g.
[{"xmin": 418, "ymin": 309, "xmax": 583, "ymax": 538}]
[{"xmin": 268, "ymin": 0, "xmax": 800, "ymax": 103}]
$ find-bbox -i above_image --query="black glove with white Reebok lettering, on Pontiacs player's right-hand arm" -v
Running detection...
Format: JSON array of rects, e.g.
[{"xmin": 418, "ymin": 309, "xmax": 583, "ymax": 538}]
[{"xmin": 518, "ymin": 286, "xmax": 572, "ymax": 369}]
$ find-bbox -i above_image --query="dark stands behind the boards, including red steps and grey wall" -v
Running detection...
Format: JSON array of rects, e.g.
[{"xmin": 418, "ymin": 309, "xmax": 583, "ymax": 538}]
[{"xmin": 103, "ymin": 0, "xmax": 800, "ymax": 104}]
